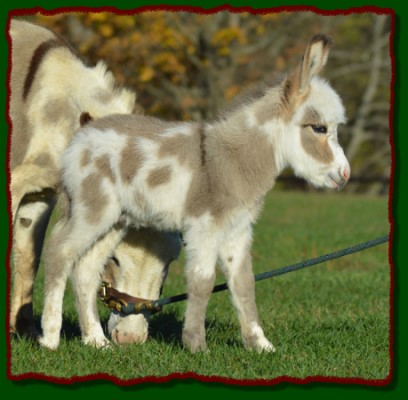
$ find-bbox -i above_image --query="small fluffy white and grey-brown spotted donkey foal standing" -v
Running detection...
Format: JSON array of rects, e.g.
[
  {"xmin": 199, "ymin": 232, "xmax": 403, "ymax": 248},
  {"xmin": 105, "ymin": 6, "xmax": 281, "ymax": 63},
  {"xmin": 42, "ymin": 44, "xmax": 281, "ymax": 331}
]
[{"xmin": 40, "ymin": 35, "xmax": 350, "ymax": 352}]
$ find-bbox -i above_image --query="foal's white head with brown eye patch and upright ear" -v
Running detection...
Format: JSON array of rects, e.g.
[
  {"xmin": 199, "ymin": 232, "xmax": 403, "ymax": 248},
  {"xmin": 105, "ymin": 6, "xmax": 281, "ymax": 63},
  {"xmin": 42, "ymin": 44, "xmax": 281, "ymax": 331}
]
[{"xmin": 280, "ymin": 35, "xmax": 350, "ymax": 189}]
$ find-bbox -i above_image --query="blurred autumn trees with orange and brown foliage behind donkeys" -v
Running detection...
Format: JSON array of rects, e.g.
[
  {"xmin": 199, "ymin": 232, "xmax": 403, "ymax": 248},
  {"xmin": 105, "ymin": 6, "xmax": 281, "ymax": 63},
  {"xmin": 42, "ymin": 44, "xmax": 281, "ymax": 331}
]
[{"xmin": 20, "ymin": 11, "xmax": 391, "ymax": 193}]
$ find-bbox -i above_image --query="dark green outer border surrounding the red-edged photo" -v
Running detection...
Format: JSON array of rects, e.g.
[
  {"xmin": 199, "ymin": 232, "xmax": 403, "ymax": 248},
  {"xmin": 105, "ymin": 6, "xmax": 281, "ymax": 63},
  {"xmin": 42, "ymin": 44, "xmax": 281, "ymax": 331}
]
[{"xmin": 0, "ymin": 0, "xmax": 408, "ymax": 400}]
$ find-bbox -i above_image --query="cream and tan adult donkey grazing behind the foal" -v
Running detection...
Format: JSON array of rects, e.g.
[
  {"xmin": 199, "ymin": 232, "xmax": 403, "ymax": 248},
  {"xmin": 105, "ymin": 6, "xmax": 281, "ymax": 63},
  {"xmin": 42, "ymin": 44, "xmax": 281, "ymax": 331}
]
[{"xmin": 9, "ymin": 19, "xmax": 180, "ymax": 343}]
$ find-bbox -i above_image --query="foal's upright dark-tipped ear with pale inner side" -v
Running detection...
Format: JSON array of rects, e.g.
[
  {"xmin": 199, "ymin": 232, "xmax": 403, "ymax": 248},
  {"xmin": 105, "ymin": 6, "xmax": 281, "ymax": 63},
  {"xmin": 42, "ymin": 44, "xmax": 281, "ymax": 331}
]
[{"xmin": 300, "ymin": 34, "xmax": 333, "ymax": 93}]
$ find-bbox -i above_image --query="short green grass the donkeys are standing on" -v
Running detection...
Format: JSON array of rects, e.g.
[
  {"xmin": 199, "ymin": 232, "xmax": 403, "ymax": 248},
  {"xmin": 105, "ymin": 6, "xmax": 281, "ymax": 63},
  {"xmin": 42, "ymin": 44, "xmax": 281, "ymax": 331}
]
[{"xmin": 11, "ymin": 190, "xmax": 391, "ymax": 382}]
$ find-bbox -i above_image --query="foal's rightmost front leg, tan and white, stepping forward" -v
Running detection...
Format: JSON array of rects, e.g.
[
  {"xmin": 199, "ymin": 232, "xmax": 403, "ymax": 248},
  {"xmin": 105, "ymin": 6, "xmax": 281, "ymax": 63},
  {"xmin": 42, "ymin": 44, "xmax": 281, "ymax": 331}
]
[{"xmin": 219, "ymin": 229, "xmax": 275, "ymax": 352}]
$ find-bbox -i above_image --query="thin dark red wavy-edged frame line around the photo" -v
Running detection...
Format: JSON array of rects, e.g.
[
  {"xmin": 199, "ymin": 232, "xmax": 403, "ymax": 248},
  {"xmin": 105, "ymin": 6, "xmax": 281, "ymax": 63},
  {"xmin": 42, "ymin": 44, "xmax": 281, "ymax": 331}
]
[{"xmin": 6, "ymin": 5, "xmax": 395, "ymax": 387}]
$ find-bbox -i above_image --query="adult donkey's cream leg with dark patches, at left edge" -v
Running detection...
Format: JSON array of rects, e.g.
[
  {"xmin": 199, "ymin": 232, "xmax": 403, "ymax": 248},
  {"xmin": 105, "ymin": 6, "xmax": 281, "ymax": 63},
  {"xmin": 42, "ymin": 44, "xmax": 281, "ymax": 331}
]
[{"xmin": 10, "ymin": 197, "xmax": 55, "ymax": 338}]
